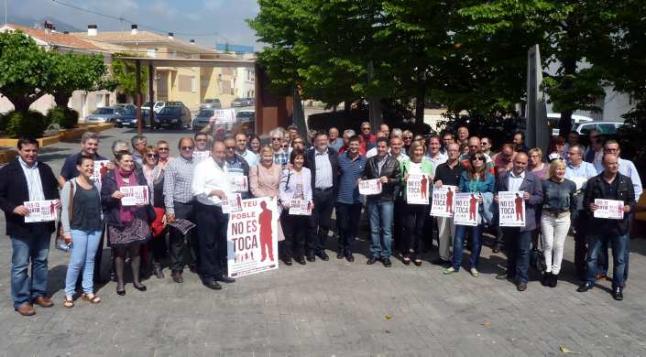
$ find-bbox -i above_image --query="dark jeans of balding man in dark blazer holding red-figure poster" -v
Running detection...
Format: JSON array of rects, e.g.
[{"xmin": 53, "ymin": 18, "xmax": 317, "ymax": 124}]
[{"xmin": 503, "ymin": 228, "xmax": 533, "ymax": 283}]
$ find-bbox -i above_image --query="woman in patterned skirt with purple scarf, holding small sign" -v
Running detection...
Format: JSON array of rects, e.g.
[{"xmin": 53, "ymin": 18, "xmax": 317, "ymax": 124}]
[{"xmin": 101, "ymin": 153, "xmax": 155, "ymax": 296}]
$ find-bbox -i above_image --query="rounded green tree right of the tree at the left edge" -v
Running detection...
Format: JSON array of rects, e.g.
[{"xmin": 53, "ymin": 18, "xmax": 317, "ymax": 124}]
[{"xmin": 48, "ymin": 53, "xmax": 107, "ymax": 108}]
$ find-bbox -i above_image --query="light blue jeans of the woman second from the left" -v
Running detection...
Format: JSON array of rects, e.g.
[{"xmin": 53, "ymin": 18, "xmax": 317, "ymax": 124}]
[{"xmin": 65, "ymin": 229, "xmax": 103, "ymax": 296}]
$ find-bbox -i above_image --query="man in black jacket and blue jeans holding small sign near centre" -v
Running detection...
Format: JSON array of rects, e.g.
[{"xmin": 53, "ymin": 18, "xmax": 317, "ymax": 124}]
[{"xmin": 360, "ymin": 138, "xmax": 401, "ymax": 268}]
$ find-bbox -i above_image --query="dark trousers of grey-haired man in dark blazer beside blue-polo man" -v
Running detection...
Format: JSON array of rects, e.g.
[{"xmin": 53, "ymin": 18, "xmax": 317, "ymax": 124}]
[{"xmin": 307, "ymin": 188, "xmax": 335, "ymax": 255}]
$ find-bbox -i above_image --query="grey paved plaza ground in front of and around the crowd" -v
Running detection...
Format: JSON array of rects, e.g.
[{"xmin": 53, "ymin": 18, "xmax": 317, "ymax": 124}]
[{"xmin": 0, "ymin": 129, "xmax": 646, "ymax": 357}]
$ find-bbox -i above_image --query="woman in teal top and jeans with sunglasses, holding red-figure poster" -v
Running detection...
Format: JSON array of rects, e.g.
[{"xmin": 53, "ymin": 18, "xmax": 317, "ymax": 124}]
[{"xmin": 444, "ymin": 151, "xmax": 494, "ymax": 277}]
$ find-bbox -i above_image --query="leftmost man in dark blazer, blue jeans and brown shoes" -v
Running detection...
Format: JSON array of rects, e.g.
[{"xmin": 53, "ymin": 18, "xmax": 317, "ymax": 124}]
[{"xmin": 0, "ymin": 139, "xmax": 60, "ymax": 316}]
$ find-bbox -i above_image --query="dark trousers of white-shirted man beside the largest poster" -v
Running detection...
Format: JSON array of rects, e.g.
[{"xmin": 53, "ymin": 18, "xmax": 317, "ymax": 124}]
[{"xmin": 195, "ymin": 202, "xmax": 229, "ymax": 281}]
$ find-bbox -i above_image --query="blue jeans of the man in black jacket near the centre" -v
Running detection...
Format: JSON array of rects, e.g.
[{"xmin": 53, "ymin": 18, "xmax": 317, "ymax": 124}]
[{"xmin": 370, "ymin": 200, "xmax": 394, "ymax": 259}]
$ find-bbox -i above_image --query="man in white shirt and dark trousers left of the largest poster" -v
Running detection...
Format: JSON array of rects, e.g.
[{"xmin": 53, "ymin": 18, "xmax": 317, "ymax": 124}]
[{"xmin": 192, "ymin": 141, "xmax": 235, "ymax": 290}]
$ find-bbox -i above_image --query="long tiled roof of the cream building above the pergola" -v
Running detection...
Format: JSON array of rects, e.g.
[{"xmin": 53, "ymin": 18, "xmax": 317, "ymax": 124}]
[{"xmin": 71, "ymin": 30, "xmax": 215, "ymax": 53}]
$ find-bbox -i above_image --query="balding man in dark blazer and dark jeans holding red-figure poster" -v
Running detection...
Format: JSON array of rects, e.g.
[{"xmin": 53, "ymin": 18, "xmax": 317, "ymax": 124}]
[{"xmin": 495, "ymin": 152, "xmax": 543, "ymax": 291}]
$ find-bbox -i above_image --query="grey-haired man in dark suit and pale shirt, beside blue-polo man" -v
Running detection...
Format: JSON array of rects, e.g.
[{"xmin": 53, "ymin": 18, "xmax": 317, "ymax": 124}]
[{"xmin": 305, "ymin": 132, "xmax": 339, "ymax": 262}]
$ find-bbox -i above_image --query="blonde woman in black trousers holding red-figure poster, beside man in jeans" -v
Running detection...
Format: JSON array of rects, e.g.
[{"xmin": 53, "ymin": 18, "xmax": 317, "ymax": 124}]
[{"xmin": 401, "ymin": 141, "xmax": 433, "ymax": 266}]
